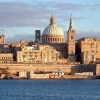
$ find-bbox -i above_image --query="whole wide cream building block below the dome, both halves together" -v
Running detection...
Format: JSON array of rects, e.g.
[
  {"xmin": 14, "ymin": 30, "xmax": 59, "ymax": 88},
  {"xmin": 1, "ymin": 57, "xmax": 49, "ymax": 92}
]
[{"xmin": 17, "ymin": 45, "xmax": 59, "ymax": 63}]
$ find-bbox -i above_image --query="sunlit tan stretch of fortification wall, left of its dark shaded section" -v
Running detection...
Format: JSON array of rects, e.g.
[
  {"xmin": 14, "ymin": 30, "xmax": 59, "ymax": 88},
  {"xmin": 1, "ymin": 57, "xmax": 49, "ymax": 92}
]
[{"xmin": 0, "ymin": 64, "xmax": 75, "ymax": 73}]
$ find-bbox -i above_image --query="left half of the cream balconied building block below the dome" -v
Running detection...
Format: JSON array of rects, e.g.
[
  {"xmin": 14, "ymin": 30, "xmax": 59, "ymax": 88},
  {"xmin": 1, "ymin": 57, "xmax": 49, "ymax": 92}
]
[{"xmin": 17, "ymin": 46, "xmax": 41, "ymax": 63}]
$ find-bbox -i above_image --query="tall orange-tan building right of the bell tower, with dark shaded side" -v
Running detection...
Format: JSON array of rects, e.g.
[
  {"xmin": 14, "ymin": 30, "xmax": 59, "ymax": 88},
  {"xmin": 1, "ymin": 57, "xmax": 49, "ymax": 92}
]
[{"xmin": 77, "ymin": 38, "xmax": 100, "ymax": 64}]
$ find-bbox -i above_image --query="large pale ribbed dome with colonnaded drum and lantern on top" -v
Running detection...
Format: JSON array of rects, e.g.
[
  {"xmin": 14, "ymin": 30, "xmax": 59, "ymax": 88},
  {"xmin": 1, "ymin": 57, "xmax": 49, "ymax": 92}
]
[{"xmin": 42, "ymin": 16, "xmax": 64, "ymax": 43}]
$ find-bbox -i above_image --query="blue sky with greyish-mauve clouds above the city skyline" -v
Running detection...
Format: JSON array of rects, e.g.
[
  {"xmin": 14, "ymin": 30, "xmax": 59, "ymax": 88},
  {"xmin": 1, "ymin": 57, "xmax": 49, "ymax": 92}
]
[{"xmin": 0, "ymin": 0, "xmax": 100, "ymax": 42}]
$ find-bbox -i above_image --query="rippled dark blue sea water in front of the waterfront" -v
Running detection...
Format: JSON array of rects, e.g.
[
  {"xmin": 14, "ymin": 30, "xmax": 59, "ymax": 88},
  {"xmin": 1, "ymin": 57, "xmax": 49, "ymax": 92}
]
[{"xmin": 0, "ymin": 80, "xmax": 100, "ymax": 100}]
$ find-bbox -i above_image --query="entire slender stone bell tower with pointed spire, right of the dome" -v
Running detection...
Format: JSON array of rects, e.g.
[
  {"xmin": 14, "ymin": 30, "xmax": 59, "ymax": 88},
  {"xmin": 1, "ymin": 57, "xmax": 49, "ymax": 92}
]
[{"xmin": 67, "ymin": 15, "xmax": 76, "ymax": 62}]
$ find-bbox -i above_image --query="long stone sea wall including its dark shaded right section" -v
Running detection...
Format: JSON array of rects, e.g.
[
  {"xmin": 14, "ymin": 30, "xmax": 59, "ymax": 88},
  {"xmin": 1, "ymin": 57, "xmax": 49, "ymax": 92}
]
[{"xmin": 0, "ymin": 64, "xmax": 97, "ymax": 75}]
